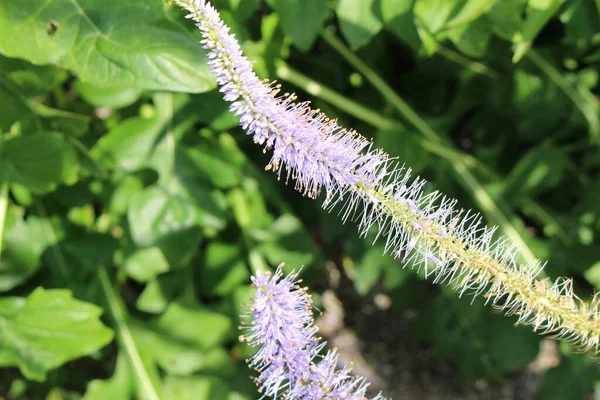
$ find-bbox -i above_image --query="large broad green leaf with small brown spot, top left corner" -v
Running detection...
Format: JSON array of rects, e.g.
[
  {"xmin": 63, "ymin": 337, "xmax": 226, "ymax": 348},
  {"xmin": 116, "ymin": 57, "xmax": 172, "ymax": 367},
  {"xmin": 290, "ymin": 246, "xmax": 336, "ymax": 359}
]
[{"xmin": 0, "ymin": 0, "xmax": 215, "ymax": 92}]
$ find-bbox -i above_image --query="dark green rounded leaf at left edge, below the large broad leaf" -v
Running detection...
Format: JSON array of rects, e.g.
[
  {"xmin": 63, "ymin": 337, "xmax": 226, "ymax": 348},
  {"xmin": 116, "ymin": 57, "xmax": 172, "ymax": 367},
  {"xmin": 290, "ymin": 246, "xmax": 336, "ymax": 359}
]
[{"xmin": 0, "ymin": 133, "xmax": 64, "ymax": 193}]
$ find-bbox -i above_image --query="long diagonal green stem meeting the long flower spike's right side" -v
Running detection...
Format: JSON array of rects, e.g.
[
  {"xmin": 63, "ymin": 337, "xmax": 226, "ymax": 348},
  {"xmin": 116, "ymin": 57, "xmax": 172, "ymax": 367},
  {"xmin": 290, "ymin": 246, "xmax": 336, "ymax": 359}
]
[{"xmin": 322, "ymin": 29, "xmax": 536, "ymax": 263}]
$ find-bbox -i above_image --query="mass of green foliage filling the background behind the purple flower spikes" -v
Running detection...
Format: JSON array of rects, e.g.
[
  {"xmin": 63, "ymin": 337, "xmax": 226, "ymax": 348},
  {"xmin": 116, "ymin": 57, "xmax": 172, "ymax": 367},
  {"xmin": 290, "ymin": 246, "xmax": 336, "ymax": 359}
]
[{"xmin": 0, "ymin": 0, "xmax": 600, "ymax": 399}]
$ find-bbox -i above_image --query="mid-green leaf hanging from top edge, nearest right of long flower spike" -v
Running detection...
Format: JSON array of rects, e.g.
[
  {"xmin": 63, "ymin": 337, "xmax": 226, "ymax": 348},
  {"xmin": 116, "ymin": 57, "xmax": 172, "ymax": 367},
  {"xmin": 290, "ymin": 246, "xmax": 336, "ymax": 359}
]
[{"xmin": 274, "ymin": 0, "xmax": 329, "ymax": 51}]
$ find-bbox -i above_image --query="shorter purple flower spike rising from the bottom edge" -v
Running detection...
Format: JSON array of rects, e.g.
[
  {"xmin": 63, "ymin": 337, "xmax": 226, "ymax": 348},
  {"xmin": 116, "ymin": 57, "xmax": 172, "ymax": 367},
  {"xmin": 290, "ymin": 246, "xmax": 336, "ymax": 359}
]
[{"xmin": 240, "ymin": 264, "xmax": 383, "ymax": 400}]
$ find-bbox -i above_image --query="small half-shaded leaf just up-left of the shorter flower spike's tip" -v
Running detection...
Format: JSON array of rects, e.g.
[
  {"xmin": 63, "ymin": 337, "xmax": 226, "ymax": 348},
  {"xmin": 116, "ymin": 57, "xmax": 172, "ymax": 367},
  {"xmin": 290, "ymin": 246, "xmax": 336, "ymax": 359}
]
[{"xmin": 200, "ymin": 242, "xmax": 249, "ymax": 296}]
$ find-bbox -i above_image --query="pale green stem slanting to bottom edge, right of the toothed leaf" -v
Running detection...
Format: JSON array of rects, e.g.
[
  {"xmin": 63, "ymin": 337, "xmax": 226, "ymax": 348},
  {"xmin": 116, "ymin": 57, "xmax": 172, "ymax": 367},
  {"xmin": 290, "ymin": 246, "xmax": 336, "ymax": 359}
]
[{"xmin": 98, "ymin": 267, "xmax": 160, "ymax": 400}]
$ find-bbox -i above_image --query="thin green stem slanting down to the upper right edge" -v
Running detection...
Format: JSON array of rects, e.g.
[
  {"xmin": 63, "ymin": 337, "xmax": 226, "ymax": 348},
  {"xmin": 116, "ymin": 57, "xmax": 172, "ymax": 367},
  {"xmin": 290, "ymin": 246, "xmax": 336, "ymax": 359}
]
[{"xmin": 525, "ymin": 48, "xmax": 600, "ymax": 144}]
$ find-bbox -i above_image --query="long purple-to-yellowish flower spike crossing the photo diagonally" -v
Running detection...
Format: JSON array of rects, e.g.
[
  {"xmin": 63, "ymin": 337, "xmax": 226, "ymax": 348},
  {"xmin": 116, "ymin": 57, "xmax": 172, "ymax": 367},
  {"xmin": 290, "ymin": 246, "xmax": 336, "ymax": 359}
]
[{"xmin": 174, "ymin": 0, "xmax": 600, "ymax": 355}]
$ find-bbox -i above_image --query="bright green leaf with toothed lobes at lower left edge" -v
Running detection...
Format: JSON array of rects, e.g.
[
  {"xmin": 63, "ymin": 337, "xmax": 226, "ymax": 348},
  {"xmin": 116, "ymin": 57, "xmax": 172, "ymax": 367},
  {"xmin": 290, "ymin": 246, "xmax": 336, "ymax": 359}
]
[{"xmin": 0, "ymin": 288, "xmax": 113, "ymax": 381}]
